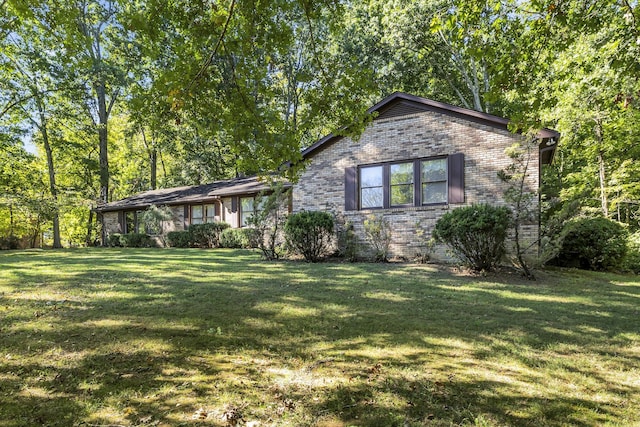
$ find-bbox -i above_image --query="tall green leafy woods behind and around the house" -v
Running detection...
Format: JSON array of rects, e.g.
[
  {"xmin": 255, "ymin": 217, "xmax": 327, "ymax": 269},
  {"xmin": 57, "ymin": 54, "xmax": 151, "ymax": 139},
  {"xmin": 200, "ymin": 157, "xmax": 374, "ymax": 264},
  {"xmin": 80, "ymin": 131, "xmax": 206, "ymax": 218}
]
[{"xmin": 0, "ymin": 0, "xmax": 640, "ymax": 247}]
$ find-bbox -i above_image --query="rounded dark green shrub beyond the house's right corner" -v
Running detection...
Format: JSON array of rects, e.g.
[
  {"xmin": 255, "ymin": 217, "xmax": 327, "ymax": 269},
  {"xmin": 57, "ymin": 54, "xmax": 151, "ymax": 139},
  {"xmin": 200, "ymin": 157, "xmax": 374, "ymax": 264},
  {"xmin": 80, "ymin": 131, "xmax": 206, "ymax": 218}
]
[{"xmin": 555, "ymin": 217, "xmax": 627, "ymax": 270}]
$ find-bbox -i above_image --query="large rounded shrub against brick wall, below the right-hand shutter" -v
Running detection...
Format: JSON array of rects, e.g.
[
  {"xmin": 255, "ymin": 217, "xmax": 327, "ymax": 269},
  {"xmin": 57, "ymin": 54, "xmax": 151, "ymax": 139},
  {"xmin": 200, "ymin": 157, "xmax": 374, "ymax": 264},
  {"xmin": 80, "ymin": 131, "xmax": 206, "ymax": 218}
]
[{"xmin": 433, "ymin": 204, "xmax": 511, "ymax": 271}]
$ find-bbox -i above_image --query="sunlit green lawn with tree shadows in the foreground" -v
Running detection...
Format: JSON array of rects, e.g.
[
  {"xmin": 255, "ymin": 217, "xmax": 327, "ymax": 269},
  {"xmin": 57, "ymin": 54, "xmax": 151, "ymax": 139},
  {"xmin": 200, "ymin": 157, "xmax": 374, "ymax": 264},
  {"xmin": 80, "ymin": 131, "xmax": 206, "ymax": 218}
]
[{"xmin": 0, "ymin": 249, "xmax": 640, "ymax": 427}]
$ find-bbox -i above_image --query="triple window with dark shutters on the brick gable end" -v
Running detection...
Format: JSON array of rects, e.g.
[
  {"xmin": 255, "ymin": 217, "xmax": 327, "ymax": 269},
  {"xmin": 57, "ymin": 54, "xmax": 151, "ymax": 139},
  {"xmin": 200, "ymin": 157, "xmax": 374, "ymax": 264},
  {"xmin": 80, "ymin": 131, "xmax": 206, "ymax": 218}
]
[{"xmin": 344, "ymin": 153, "xmax": 464, "ymax": 211}]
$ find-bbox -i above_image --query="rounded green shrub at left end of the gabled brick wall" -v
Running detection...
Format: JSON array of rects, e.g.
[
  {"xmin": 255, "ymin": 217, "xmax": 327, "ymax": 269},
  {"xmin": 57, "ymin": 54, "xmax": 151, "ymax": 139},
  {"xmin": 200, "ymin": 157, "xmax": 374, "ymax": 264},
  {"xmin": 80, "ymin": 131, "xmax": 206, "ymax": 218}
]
[{"xmin": 284, "ymin": 211, "xmax": 333, "ymax": 262}]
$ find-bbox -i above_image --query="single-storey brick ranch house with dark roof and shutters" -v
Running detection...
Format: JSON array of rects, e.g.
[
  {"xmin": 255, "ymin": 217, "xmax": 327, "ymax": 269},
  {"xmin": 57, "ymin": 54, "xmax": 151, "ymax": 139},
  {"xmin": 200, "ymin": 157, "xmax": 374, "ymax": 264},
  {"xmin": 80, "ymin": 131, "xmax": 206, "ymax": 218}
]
[{"xmin": 96, "ymin": 92, "xmax": 560, "ymax": 258}]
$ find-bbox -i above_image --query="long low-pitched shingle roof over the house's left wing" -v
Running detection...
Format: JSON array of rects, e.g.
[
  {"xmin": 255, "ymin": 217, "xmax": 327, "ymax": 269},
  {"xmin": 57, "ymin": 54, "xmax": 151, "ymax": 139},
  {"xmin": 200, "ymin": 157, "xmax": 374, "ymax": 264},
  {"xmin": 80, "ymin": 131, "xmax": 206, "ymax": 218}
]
[{"xmin": 95, "ymin": 176, "xmax": 291, "ymax": 212}]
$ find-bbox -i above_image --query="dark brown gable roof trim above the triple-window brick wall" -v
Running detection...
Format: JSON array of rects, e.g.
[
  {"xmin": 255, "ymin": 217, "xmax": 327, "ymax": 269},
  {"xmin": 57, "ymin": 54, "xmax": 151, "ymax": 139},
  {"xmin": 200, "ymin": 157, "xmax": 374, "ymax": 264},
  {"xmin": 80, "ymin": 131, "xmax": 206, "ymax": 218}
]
[{"xmin": 302, "ymin": 92, "xmax": 560, "ymax": 164}]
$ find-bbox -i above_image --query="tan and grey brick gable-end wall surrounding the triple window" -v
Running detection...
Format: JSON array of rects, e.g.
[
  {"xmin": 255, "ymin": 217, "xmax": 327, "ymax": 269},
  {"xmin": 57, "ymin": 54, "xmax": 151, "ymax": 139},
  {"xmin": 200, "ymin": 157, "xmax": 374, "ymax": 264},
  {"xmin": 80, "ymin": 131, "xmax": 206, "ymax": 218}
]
[{"xmin": 293, "ymin": 112, "xmax": 539, "ymax": 259}]
